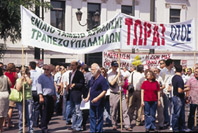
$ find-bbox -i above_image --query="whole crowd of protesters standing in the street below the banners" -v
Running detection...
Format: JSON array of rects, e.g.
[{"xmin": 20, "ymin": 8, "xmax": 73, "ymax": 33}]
[{"xmin": 0, "ymin": 59, "xmax": 198, "ymax": 133}]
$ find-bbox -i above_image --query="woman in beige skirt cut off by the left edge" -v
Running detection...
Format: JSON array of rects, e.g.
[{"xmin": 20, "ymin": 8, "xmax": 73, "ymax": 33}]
[{"xmin": 0, "ymin": 67, "xmax": 11, "ymax": 132}]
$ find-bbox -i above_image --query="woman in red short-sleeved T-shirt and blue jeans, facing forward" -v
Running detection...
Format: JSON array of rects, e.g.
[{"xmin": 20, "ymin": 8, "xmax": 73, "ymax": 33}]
[{"xmin": 141, "ymin": 70, "xmax": 160, "ymax": 132}]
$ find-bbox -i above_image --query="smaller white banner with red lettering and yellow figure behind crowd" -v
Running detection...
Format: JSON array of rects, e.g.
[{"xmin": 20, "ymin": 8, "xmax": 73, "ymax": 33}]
[{"xmin": 102, "ymin": 51, "xmax": 172, "ymax": 68}]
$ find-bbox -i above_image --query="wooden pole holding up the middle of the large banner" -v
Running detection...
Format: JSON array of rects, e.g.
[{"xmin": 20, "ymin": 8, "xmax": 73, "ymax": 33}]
[{"xmin": 118, "ymin": 49, "xmax": 123, "ymax": 130}]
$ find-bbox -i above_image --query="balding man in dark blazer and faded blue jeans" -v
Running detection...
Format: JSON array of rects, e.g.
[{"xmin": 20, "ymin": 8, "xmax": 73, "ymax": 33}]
[{"xmin": 66, "ymin": 61, "xmax": 85, "ymax": 131}]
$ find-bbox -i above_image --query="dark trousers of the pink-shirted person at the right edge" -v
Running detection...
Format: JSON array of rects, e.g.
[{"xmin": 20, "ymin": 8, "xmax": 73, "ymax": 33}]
[{"xmin": 188, "ymin": 104, "xmax": 198, "ymax": 130}]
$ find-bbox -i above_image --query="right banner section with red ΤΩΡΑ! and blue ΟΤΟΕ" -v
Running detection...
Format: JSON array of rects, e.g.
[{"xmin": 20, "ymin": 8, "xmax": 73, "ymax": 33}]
[{"xmin": 121, "ymin": 14, "xmax": 195, "ymax": 51}]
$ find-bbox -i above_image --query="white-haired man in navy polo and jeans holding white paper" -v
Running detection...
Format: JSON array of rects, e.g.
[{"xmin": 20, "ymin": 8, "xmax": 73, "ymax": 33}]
[{"xmin": 85, "ymin": 63, "xmax": 109, "ymax": 132}]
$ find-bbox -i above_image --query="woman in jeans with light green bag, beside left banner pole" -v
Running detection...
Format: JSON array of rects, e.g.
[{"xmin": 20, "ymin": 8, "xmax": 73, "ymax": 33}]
[{"xmin": 16, "ymin": 69, "xmax": 33, "ymax": 133}]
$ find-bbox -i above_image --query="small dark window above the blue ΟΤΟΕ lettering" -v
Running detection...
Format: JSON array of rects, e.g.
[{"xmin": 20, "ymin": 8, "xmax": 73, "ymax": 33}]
[{"xmin": 170, "ymin": 9, "xmax": 181, "ymax": 23}]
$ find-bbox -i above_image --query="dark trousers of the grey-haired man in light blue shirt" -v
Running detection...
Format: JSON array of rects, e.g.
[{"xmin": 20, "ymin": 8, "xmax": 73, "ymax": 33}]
[{"xmin": 41, "ymin": 96, "xmax": 54, "ymax": 133}]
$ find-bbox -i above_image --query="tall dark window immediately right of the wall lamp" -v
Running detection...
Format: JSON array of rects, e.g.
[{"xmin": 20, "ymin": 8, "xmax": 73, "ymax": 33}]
[{"xmin": 87, "ymin": 3, "xmax": 100, "ymax": 30}]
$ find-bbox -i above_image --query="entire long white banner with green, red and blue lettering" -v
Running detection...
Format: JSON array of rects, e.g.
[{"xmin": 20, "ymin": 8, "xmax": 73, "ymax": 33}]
[{"xmin": 21, "ymin": 6, "xmax": 195, "ymax": 54}]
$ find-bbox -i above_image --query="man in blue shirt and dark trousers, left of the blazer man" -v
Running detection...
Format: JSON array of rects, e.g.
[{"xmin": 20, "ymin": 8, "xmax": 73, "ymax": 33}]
[{"xmin": 37, "ymin": 65, "xmax": 56, "ymax": 133}]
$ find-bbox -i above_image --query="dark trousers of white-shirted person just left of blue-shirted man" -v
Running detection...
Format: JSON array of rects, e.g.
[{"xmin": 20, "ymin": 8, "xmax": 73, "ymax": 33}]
[{"xmin": 32, "ymin": 91, "xmax": 41, "ymax": 127}]
